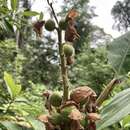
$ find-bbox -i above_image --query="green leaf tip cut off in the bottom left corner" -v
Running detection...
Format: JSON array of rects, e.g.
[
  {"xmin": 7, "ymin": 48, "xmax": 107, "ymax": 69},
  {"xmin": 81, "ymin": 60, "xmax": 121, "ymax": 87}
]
[{"xmin": 0, "ymin": 121, "xmax": 22, "ymax": 130}]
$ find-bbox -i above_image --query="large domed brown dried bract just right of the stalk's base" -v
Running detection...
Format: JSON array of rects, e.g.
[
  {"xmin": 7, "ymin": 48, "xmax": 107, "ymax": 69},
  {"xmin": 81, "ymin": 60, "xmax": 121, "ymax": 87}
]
[{"xmin": 70, "ymin": 86, "xmax": 97, "ymax": 103}]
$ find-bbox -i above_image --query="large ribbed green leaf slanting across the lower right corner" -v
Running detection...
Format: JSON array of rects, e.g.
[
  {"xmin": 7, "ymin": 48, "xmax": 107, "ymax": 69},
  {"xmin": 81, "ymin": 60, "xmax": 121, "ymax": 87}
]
[{"xmin": 97, "ymin": 88, "xmax": 130, "ymax": 130}]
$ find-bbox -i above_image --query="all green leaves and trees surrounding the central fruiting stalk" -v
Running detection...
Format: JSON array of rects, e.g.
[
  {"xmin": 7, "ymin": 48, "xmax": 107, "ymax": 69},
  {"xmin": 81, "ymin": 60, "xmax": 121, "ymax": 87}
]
[{"xmin": 0, "ymin": 0, "xmax": 130, "ymax": 130}]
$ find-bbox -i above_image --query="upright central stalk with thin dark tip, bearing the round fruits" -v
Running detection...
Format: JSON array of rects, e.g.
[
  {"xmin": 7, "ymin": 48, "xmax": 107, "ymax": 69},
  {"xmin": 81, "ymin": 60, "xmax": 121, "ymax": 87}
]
[{"xmin": 47, "ymin": 0, "xmax": 69, "ymax": 102}]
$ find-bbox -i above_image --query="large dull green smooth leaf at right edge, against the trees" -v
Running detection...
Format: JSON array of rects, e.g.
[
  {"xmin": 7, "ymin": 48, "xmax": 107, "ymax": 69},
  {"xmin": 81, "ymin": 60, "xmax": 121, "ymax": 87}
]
[{"xmin": 108, "ymin": 32, "xmax": 130, "ymax": 74}]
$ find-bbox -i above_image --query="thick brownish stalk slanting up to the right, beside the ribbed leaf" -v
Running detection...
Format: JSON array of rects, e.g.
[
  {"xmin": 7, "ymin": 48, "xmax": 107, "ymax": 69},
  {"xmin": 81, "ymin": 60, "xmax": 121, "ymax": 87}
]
[{"xmin": 96, "ymin": 78, "xmax": 117, "ymax": 107}]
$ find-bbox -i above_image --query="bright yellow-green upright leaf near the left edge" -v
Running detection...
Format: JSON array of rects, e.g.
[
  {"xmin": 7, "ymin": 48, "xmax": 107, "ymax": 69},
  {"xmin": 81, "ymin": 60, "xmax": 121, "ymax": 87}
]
[{"xmin": 4, "ymin": 72, "xmax": 21, "ymax": 98}]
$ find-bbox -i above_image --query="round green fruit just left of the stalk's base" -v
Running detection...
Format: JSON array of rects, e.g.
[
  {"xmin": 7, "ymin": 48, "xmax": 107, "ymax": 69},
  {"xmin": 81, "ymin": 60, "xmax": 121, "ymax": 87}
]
[{"xmin": 50, "ymin": 92, "xmax": 62, "ymax": 107}]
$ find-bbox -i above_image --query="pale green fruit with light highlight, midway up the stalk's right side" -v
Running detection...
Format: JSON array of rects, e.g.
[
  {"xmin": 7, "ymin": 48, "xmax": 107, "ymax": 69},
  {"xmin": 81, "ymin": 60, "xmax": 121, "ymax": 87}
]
[{"xmin": 63, "ymin": 43, "xmax": 75, "ymax": 57}]
